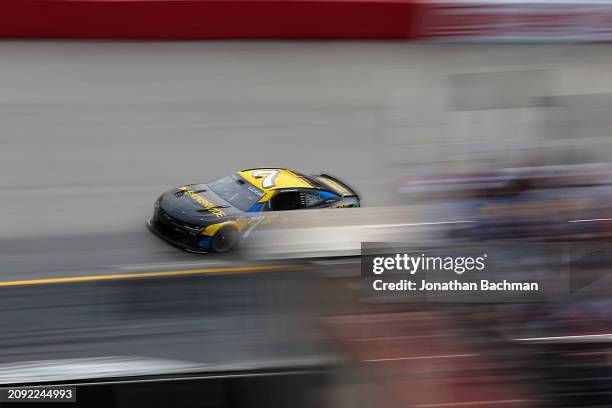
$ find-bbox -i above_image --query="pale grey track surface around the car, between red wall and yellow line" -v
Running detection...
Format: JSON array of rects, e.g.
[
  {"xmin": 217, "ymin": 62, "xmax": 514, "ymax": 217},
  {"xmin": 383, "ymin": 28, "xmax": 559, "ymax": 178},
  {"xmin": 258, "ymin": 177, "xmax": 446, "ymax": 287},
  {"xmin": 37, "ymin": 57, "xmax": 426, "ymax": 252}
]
[{"xmin": 0, "ymin": 41, "xmax": 610, "ymax": 281}]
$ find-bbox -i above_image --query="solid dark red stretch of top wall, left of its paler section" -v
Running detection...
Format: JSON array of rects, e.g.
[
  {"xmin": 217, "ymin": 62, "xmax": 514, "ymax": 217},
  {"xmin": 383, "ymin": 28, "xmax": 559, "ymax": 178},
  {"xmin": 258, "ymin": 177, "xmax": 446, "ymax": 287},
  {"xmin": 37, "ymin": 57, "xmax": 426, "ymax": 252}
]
[{"xmin": 0, "ymin": 0, "xmax": 418, "ymax": 39}]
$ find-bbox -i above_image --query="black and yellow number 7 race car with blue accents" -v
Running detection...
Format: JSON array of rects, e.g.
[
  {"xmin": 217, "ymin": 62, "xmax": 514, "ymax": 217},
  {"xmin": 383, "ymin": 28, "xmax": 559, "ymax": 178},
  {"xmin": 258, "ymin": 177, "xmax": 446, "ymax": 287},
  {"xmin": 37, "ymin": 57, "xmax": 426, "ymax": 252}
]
[{"xmin": 148, "ymin": 168, "xmax": 360, "ymax": 253}]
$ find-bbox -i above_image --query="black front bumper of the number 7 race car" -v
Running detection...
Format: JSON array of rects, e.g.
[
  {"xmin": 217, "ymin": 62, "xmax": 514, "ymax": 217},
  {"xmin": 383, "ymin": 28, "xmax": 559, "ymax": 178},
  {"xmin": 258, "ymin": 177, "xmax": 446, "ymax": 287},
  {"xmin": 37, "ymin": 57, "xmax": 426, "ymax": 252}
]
[{"xmin": 147, "ymin": 206, "xmax": 212, "ymax": 253}]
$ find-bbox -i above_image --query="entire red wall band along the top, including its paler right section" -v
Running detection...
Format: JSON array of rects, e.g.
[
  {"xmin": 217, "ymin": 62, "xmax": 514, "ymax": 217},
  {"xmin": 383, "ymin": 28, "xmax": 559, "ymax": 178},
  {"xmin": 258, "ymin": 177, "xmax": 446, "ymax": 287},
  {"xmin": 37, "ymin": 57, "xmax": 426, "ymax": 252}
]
[{"xmin": 0, "ymin": 0, "xmax": 612, "ymax": 41}]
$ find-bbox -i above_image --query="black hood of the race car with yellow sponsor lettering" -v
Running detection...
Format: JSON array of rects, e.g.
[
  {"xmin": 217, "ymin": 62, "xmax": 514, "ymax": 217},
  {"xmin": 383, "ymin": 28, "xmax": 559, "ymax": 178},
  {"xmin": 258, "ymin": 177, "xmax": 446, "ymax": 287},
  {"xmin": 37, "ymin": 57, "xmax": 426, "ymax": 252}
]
[{"xmin": 159, "ymin": 184, "xmax": 243, "ymax": 226}]
